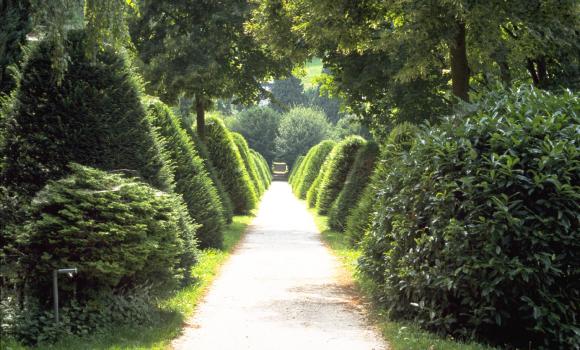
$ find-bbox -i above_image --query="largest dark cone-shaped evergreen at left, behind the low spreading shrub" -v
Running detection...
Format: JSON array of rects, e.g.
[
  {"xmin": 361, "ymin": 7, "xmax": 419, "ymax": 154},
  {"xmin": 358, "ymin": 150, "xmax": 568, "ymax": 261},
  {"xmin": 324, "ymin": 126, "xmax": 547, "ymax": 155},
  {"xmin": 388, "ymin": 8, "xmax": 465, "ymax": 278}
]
[{"xmin": 2, "ymin": 32, "xmax": 172, "ymax": 198}]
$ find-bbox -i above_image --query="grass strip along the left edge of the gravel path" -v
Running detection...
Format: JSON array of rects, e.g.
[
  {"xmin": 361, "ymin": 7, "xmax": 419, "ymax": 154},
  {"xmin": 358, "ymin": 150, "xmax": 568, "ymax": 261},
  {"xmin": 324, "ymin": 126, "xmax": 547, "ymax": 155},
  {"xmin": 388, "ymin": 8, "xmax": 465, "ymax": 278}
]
[{"xmin": 0, "ymin": 216, "xmax": 253, "ymax": 350}]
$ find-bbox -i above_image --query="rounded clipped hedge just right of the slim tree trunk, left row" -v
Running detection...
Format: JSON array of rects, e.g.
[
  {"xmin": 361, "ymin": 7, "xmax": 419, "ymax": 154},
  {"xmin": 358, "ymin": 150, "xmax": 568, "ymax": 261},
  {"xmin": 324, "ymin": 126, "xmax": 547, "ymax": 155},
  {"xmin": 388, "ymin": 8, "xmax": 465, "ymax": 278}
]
[{"xmin": 205, "ymin": 116, "xmax": 258, "ymax": 214}]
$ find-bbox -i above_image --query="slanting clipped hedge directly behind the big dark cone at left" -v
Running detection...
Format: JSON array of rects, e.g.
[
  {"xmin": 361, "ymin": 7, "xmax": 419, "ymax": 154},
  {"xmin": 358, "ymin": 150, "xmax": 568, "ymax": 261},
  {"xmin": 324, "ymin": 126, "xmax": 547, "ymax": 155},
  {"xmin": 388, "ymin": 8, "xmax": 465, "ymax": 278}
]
[{"xmin": 146, "ymin": 99, "xmax": 225, "ymax": 248}]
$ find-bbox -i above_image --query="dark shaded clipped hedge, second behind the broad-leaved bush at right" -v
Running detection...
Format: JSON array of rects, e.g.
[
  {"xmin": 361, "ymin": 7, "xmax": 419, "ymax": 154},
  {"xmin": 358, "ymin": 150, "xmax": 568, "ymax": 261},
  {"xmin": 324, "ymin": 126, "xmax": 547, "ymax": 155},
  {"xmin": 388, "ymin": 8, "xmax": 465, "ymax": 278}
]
[{"xmin": 328, "ymin": 142, "xmax": 379, "ymax": 232}]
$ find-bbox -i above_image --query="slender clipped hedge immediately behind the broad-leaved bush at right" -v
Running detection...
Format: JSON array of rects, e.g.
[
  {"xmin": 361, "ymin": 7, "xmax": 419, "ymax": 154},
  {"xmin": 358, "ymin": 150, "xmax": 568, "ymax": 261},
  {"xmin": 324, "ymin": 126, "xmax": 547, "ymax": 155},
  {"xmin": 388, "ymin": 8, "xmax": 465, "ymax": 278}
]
[{"xmin": 345, "ymin": 122, "xmax": 419, "ymax": 246}]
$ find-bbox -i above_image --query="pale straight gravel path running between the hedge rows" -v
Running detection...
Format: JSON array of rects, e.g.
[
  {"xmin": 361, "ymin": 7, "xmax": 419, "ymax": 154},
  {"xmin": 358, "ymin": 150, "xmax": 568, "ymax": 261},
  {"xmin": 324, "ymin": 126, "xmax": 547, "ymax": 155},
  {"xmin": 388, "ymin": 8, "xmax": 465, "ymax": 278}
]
[{"xmin": 173, "ymin": 182, "xmax": 388, "ymax": 350}]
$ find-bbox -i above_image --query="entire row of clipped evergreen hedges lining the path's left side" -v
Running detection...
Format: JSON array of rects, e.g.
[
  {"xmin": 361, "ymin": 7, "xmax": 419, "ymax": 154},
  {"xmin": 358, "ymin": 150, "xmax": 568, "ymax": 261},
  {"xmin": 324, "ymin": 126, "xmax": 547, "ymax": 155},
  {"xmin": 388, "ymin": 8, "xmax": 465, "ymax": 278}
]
[{"xmin": 0, "ymin": 28, "xmax": 271, "ymax": 342}]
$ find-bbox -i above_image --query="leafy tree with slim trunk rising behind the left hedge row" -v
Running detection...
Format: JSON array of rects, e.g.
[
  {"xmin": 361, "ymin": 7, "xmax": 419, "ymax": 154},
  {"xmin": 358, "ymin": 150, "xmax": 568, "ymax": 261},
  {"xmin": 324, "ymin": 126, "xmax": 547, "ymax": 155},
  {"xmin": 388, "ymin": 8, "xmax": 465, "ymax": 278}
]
[{"xmin": 130, "ymin": 0, "xmax": 291, "ymax": 138}]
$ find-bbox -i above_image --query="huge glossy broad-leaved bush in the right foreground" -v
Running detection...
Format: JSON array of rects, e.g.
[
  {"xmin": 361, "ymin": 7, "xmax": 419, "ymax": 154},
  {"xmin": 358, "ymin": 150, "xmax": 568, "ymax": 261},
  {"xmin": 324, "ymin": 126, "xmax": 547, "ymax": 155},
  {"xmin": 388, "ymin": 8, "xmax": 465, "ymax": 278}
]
[{"xmin": 360, "ymin": 88, "xmax": 580, "ymax": 349}]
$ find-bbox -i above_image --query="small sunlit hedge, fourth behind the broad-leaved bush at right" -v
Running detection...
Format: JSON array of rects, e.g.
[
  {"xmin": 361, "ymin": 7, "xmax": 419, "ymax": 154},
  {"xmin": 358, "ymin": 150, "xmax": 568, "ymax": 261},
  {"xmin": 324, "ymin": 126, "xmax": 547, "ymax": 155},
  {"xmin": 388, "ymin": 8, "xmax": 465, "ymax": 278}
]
[{"xmin": 293, "ymin": 140, "xmax": 336, "ymax": 200}]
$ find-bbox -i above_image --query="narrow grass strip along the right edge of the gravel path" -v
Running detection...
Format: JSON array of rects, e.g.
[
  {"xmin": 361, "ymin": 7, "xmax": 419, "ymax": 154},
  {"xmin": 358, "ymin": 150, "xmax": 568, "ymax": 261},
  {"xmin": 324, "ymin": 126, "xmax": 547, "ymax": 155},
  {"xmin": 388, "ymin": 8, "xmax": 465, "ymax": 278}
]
[{"xmin": 310, "ymin": 209, "xmax": 494, "ymax": 350}]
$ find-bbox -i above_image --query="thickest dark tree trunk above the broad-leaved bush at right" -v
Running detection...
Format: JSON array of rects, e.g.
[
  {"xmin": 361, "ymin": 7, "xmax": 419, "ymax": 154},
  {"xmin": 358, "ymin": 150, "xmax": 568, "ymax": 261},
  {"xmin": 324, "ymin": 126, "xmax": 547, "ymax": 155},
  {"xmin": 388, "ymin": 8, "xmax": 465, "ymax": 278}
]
[{"xmin": 449, "ymin": 21, "xmax": 469, "ymax": 101}]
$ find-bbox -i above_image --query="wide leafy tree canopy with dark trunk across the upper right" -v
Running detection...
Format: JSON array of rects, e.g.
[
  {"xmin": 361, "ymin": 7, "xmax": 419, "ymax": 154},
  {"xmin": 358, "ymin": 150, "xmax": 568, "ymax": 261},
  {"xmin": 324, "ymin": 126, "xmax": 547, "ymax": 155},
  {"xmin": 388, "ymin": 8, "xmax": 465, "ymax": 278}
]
[{"xmin": 250, "ymin": 0, "xmax": 580, "ymax": 108}]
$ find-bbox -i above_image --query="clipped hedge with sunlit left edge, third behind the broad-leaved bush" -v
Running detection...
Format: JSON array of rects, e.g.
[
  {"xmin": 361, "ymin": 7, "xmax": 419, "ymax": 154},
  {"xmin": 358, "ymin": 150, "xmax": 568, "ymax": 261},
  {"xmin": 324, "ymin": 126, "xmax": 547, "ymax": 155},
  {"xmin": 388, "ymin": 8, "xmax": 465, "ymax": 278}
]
[{"xmin": 316, "ymin": 136, "xmax": 365, "ymax": 215}]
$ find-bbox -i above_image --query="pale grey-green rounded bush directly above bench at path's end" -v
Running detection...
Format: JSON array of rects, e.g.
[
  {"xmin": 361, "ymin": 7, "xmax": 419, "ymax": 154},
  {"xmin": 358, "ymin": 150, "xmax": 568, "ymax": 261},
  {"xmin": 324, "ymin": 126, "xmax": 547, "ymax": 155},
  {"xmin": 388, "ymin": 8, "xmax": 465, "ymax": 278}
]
[{"xmin": 275, "ymin": 107, "xmax": 330, "ymax": 164}]
